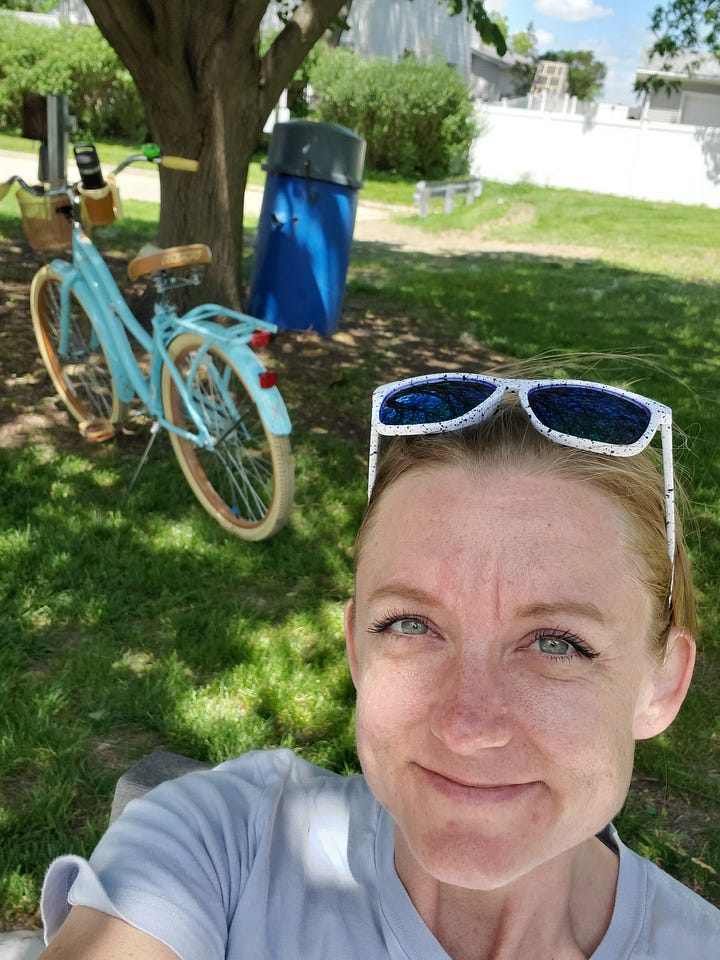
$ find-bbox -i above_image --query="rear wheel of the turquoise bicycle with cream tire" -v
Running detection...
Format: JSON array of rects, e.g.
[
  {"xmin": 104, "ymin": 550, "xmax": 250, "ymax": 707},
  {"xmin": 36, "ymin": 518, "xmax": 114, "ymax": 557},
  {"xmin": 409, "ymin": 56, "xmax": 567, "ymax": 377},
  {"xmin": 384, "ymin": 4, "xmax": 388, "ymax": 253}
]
[{"xmin": 162, "ymin": 333, "xmax": 295, "ymax": 540}]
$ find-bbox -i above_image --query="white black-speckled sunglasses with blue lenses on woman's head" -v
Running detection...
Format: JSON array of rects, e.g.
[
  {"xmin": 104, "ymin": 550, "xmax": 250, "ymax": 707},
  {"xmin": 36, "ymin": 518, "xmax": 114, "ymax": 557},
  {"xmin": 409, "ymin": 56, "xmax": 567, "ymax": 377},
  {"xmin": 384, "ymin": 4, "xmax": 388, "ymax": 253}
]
[{"xmin": 368, "ymin": 373, "xmax": 675, "ymax": 576}]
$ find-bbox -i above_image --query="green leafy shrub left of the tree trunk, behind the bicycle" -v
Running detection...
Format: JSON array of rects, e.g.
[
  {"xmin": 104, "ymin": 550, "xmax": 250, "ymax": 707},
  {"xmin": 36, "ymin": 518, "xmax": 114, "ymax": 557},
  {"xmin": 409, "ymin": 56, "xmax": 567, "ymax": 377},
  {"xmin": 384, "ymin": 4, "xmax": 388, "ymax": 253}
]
[{"xmin": 0, "ymin": 14, "xmax": 147, "ymax": 143}]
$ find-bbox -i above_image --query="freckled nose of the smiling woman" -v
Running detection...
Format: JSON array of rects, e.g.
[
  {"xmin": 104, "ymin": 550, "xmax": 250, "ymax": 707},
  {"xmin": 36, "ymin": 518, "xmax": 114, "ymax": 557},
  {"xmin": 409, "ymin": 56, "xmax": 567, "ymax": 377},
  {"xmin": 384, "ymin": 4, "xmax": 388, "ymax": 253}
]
[{"xmin": 431, "ymin": 657, "xmax": 515, "ymax": 756}]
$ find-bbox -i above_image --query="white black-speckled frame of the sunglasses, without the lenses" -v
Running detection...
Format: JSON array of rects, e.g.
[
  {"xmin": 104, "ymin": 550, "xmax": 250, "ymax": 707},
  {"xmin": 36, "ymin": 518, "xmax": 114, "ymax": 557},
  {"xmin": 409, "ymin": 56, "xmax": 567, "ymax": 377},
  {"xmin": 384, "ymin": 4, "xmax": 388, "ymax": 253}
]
[{"xmin": 368, "ymin": 373, "xmax": 675, "ymax": 576}]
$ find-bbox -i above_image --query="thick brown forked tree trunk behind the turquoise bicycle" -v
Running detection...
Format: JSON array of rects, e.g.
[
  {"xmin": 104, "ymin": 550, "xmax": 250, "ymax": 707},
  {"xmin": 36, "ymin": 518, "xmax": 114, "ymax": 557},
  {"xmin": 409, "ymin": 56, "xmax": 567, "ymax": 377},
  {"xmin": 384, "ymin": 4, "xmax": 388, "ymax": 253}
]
[{"xmin": 87, "ymin": 0, "xmax": 342, "ymax": 308}]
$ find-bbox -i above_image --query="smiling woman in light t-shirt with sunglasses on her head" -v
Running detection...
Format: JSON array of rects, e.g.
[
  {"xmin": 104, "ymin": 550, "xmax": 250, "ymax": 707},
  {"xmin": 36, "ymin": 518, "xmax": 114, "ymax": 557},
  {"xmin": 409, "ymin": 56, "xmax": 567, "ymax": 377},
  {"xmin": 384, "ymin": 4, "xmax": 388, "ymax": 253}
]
[{"xmin": 43, "ymin": 374, "xmax": 720, "ymax": 960}]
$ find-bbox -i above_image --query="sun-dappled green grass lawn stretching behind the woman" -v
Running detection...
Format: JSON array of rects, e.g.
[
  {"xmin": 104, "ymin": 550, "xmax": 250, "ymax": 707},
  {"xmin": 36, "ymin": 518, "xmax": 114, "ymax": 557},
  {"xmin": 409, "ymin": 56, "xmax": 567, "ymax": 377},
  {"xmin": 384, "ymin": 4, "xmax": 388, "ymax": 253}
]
[{"xmin": 0, "ymin": 159, "xmax": 720, "ymax": 926}]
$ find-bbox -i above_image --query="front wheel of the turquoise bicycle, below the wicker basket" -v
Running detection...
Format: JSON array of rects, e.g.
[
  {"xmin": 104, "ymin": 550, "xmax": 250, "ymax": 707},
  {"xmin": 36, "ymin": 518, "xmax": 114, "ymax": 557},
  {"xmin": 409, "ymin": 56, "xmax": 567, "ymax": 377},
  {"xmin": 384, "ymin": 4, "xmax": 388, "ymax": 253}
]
[{"xmin": 30, "ymin": 266, "xmax": 127, "ymax": 423}]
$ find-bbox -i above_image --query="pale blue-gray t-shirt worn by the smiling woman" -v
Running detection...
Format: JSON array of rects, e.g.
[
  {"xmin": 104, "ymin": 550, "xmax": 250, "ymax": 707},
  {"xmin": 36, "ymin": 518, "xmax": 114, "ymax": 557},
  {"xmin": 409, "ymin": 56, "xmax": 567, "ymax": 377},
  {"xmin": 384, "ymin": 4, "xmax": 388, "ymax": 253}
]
[{"xmin": 42, "ymin": 750, "xmax": 720, "ymax": 960}]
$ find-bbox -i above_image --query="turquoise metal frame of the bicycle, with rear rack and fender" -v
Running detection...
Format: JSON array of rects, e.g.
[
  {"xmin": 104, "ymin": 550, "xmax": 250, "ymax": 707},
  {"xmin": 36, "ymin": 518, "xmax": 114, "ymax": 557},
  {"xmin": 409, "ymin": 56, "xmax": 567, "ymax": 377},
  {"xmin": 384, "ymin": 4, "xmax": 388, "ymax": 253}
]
[{"xmin": 51, "ymin": 223, "xmax": 291, "ymax": 448}]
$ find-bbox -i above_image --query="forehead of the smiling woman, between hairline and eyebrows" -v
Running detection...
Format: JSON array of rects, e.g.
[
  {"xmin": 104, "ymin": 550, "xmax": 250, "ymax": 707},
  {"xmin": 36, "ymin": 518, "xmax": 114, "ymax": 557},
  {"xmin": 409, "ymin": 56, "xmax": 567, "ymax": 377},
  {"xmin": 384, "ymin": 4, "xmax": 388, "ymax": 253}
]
[{"xmin": 357, "ymin": 467, "xmax": 638, "ymax": 603}]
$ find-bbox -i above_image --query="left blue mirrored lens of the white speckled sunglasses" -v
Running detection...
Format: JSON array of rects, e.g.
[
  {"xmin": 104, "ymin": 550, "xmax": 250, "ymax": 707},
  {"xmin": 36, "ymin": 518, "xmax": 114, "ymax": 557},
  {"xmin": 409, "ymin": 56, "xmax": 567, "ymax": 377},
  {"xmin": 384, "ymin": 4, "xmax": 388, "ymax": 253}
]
[{"xmin": 380, "ymin": 380, "xmax": 497, "ymax": 427}]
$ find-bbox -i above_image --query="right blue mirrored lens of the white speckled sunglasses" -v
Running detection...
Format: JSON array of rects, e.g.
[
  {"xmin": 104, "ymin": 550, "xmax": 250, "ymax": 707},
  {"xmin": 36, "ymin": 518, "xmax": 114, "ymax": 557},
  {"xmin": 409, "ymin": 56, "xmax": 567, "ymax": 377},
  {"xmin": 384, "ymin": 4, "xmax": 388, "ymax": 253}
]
[{"xmin": 528, "ymin": 385, "xmax": 651, "ymax": 446}]
